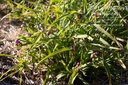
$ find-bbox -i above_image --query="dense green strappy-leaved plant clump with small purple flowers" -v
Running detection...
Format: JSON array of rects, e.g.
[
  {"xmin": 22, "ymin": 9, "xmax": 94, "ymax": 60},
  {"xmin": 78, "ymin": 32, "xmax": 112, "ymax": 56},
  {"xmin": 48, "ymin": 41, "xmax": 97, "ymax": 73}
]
[{"xmin": 1, "ymin": 0, "xmax": 128, "ymax": 85}]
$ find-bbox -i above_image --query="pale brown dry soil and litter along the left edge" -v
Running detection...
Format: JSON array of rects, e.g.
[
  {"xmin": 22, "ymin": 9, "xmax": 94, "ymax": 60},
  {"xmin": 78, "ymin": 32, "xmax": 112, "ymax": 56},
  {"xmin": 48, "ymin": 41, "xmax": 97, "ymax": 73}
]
[{"xmin": 0, "ymin": 4, "xmax": 34, "ymax": 85}]
